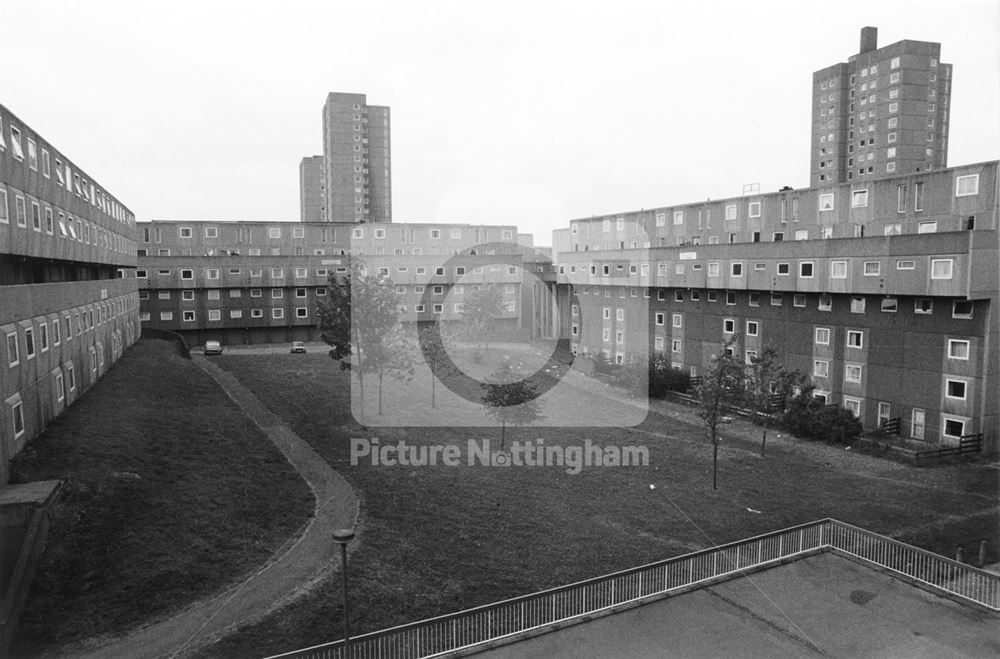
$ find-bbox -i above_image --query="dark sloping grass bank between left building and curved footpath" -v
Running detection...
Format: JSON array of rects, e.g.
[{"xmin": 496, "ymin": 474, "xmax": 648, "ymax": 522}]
[{"xmin": 7, "ymin": 339, "xmax": 314, "ymax": 656}]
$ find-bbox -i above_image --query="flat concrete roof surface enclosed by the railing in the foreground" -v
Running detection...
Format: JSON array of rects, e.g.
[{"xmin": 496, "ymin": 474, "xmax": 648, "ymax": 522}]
[{"xmin": 476, "ymin": 552, "xmax": 1000, "ymax": 659}]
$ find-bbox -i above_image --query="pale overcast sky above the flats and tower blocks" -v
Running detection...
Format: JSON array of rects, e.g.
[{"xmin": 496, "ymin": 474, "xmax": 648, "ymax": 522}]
[{"xmin": 0, "ymin": 0, "xmax": 1000, "ymax": 245}]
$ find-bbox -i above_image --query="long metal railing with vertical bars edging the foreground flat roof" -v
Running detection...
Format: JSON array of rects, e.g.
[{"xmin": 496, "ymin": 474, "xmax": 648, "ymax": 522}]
[{"xmin": 262, "ymin": 519, "xmax": 1000, "ymax": 659}]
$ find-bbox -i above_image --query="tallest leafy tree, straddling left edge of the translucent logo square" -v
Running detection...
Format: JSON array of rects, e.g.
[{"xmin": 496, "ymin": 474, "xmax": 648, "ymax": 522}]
[{"xmin": 317, "ymin": 259, "xmax": 399, "ymax": 413}]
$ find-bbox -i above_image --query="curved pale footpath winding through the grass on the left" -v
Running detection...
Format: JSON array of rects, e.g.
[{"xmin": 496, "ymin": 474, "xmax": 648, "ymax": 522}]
[{"xmin": 63, "ymin": 355, "xmax": 359, "ymax": 659}]
